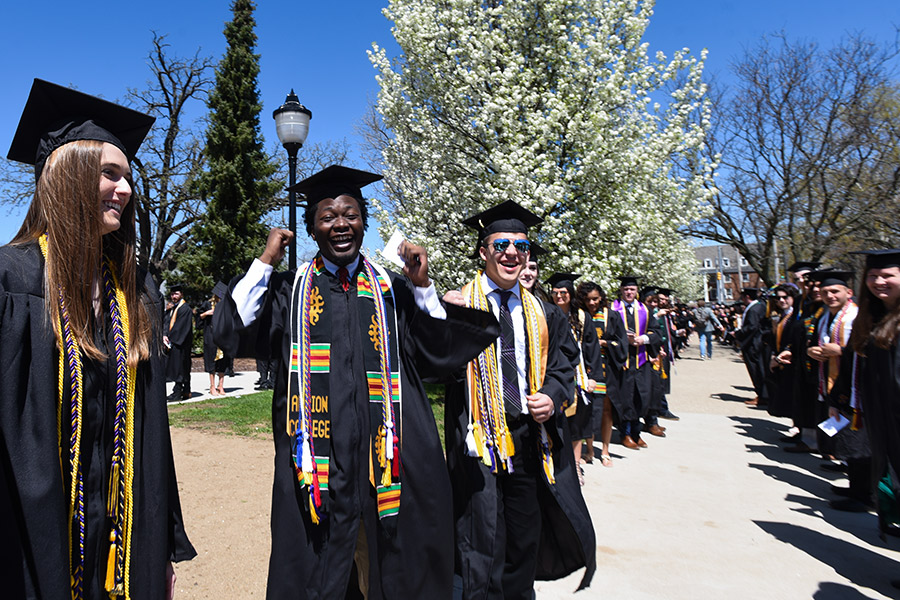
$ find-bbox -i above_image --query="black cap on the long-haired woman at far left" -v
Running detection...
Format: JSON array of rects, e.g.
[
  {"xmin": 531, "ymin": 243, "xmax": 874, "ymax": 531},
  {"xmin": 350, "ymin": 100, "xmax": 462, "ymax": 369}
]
[{"xmin": 6, "ymin": 79, "xmax": 156, "ymax": 179}]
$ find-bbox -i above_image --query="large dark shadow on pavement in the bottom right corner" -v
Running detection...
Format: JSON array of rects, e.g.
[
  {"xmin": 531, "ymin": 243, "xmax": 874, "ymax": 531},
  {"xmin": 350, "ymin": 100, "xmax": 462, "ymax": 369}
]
[{"xmin": 754, "ymin": 521, "xmax": 900, "ymax": 600}]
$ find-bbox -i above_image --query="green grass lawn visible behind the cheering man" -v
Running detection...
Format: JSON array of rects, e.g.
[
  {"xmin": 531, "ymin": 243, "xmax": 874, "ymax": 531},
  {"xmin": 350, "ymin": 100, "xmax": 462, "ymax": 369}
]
[{"xmin": 169, "ymin": 384, "xmax": 444, "ymax": 443}]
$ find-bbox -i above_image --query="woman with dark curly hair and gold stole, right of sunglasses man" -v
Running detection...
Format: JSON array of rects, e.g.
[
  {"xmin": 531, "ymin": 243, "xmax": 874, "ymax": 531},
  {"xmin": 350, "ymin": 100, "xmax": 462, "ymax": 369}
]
[{"xmin": 575, "ymin": 281, "xmax": 628, "ymax": 467}]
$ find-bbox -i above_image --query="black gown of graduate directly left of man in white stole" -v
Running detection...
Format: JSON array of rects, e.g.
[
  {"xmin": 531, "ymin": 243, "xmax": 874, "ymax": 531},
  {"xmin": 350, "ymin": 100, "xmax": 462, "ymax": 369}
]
[{"xmin": 790, "ymin": 302, "xmax": 825, "ymax": 428}]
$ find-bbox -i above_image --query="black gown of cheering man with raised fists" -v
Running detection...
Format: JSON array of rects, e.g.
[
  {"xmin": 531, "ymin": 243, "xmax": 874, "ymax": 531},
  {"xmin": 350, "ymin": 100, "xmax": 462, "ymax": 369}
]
[{"xmin": 213, "ymin": 262, "xmax": 500, "ymax": 600}]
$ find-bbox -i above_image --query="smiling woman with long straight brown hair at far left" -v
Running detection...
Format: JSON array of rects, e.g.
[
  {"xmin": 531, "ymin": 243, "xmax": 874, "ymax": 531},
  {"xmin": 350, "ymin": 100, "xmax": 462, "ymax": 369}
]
[{"xmin": 0, "ymin": 80, "xmax": 196, "ymax": 599}]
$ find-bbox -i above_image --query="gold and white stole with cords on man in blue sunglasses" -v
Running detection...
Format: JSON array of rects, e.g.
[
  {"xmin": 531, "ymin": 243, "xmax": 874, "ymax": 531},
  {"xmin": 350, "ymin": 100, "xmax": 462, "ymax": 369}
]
[{"xmin": 462, "ymin": 271, "xmax": 556, "ymax": 484}]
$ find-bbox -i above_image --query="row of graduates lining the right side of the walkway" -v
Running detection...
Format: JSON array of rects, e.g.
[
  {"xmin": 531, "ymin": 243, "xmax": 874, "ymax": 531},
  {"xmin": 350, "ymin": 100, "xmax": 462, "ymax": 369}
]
[{"xmin": 729, "ymin": 260, "xmax": 900, "ymax": 548}]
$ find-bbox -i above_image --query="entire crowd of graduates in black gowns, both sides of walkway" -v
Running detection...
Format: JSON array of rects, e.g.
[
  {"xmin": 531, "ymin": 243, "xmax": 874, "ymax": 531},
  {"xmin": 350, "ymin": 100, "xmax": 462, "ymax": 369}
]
[{"xmin": 0, "ymin": 80, "xmax": 900, "ymax": 600}]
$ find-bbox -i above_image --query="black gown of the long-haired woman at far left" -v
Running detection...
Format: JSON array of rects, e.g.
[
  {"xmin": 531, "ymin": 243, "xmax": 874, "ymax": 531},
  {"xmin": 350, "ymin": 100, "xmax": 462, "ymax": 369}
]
[{"xmin": 0, "ymin": 243, "xmax": 196, "ymax": 600}]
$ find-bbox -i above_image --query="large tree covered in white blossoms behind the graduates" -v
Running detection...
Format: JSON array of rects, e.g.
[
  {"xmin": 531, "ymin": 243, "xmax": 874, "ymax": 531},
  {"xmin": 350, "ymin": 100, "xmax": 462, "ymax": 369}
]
[{"xmin": 367, "ymin": 0, "xmax": 712, "ymax": 295}]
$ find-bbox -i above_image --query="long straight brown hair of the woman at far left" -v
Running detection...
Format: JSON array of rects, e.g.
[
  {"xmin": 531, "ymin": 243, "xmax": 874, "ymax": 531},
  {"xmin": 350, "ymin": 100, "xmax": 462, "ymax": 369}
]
[{"xmin": 10, "ymin": 140, "xmax": 154, "ymax": 365}]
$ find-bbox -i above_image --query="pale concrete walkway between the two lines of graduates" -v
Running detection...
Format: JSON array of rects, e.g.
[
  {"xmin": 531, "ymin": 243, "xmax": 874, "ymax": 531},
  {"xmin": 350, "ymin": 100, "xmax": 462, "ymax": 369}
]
[{"xmin": 537, "ymin": 341, "xmax": 900, "ymax": 600}]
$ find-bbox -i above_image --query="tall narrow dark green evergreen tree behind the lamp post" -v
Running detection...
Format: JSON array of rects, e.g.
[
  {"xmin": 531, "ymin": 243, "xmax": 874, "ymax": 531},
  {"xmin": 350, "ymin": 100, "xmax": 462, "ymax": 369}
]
[{"xmin": 179, "ymin": 0, "xmax": 281, "ymax": 290}]
